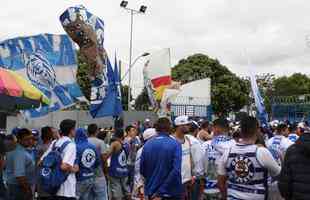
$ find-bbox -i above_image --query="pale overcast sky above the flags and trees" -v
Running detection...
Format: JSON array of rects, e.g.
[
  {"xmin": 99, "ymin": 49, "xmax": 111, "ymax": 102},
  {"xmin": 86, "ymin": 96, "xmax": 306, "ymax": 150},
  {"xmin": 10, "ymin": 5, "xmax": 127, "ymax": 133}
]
[{"xmin": 0, "ymin": 0, "xmax": 310, "ymax": 96}]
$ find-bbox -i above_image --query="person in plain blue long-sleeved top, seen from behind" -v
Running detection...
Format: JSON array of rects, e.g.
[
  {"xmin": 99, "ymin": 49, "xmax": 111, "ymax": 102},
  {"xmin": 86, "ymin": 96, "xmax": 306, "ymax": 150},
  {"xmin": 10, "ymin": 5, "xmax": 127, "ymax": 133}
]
[{"xmin": 140, "ymin": 118, "xmax": 183, "ymax": 200}]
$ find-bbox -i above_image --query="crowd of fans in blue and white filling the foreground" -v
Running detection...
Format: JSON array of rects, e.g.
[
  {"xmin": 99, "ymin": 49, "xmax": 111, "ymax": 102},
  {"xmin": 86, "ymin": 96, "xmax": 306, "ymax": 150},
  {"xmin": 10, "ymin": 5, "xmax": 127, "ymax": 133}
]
[{"xmin": 0, "ymin": 116, "xmax": 310, "ymax": 200}]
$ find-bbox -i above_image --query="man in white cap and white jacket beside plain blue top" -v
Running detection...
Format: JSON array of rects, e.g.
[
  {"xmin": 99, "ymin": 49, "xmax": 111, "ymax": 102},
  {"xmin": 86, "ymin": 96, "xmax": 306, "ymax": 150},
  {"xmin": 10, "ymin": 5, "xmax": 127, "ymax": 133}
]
[{"xmin": 173, "ymin": 116, "xmax": 207, "ymax": 200}]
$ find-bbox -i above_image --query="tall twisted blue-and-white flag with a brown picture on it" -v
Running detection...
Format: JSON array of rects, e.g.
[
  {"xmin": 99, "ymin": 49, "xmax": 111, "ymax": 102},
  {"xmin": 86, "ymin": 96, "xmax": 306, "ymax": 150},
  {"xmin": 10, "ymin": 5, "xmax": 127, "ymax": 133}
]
[{"xmin": 60, "ymin": 5, "xmax": 122, "ymax": 118}]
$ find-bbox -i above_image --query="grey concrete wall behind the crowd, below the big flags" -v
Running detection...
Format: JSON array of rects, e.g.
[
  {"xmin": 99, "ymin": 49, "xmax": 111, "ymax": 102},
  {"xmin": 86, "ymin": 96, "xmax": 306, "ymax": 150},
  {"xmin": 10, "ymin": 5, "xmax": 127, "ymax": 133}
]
[{"xmin": 6, "ymin": 111, "xmax": 157, "ymax": 132}]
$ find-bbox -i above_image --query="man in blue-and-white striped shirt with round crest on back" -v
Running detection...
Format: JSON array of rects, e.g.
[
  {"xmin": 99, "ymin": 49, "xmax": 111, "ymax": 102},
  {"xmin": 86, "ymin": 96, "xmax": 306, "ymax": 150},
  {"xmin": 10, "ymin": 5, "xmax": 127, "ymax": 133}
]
[{"xmin": 217, "ymin": 117, "xmax": 281, "ymax": 200}]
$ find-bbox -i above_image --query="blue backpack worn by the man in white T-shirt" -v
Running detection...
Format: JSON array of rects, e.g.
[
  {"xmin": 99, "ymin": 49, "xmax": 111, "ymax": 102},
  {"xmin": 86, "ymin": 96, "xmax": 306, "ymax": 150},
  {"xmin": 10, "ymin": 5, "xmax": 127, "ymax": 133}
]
[{"xmin": 39, "ymin": 141, "xmax": 70, "ymax": 195}]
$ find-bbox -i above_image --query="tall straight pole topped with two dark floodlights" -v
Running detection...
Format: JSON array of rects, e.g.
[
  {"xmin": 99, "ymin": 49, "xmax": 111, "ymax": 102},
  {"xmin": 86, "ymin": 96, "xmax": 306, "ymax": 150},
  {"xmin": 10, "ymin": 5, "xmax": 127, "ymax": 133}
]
[{"xmin": 120, "ymin": 1, "xmax": 147, "ymax": 111}]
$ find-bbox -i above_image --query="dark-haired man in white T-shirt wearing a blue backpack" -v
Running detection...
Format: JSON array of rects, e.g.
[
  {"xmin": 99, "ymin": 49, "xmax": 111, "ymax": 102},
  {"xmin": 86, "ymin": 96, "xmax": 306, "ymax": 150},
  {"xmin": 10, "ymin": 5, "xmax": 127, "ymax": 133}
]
[{"xmin": 41, "ymin": 119, "xmax": 79, "ymax": 200}]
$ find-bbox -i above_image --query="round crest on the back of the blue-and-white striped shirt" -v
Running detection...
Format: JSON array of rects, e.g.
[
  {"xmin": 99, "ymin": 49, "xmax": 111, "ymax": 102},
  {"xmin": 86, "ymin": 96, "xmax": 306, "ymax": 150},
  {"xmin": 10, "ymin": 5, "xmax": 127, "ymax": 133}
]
[{"xmin": 230, "ymin": 156, "xmax": 255, "ymax": 184}]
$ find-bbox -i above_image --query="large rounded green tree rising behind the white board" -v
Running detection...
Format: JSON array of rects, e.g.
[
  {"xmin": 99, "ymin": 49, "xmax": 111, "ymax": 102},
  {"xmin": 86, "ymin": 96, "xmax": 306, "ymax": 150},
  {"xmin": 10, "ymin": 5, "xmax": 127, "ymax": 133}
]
[{"xmin": 172, "ymin": 54, "xmax": 249, "ymax": 115}]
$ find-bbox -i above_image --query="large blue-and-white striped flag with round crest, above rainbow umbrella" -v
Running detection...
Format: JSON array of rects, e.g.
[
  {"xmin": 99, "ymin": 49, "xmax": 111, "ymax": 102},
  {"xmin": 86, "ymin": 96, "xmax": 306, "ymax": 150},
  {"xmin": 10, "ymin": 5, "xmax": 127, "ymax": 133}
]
[{"xmin": 0, "ymin": 34, "xmax": 85, "ymax": 118}]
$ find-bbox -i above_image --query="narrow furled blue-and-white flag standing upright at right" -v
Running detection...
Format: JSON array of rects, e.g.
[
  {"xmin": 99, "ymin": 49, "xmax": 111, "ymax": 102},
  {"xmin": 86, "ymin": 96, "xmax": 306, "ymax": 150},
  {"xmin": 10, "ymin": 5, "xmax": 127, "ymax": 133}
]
[{"xmin": 250, "ymin": 73, "xmax": 268, "ymax": 127}]
